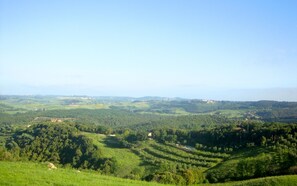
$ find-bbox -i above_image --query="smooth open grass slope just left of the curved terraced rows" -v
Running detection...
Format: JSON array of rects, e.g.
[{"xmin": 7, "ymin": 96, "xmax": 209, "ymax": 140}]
[{"xmin": 83, "ymin": 133, "xmax": 141, "ymax": 177}]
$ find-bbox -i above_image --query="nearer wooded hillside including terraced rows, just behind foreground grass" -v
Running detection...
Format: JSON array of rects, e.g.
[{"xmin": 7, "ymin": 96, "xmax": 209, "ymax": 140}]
[{"xmin": 0, "ymin": 119, "xmax": 297, "ymax": 185}]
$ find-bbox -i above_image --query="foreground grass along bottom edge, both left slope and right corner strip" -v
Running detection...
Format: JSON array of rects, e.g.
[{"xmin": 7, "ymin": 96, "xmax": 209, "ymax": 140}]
[{"xmin": 0, "ymin": 161, "xmax": 297, "ymax": 186}]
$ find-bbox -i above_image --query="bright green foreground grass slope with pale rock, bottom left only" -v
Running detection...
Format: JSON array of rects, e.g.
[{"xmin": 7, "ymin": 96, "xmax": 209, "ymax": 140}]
[{"xmin": 0, "ymin": 161, "xmax": 164, "ymax": 186}]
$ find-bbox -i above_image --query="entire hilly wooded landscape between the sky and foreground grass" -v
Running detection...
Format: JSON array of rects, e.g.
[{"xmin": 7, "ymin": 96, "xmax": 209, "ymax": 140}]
[{"xmin": 0, "ymin": 96, "xmax": 297, "ymax": 185}]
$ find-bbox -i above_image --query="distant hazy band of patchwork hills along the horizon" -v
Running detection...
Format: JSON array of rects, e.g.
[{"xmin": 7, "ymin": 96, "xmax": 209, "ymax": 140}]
[{"xmin": 0, "ymin": 95, "xmax": 297, "ymax": 122}]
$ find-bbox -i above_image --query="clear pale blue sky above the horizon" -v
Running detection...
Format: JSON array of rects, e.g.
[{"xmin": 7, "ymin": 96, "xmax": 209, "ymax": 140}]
[{"xmin": 0, "ymin": 0, "xmax": 297, "ymax": 101}]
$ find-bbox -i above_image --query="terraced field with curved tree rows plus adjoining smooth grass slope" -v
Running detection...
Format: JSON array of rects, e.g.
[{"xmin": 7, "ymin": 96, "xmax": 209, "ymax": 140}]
[{"xmin": 83, "ymin": 133, "xmax": 229, "ymax": 174}]
